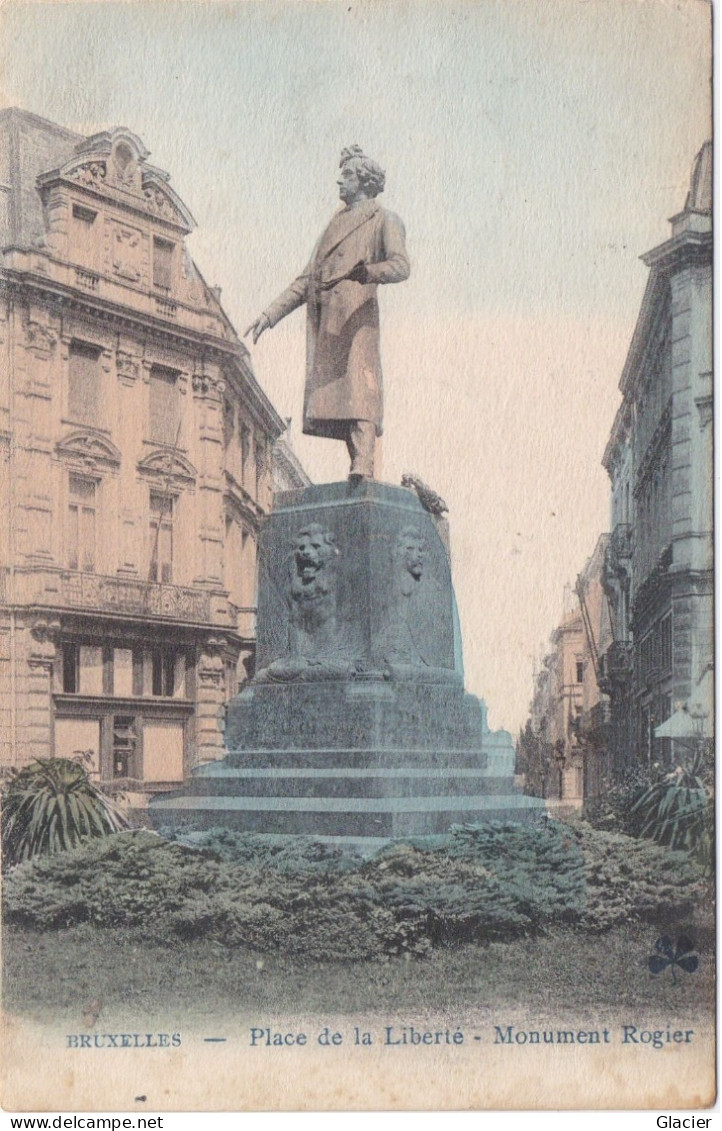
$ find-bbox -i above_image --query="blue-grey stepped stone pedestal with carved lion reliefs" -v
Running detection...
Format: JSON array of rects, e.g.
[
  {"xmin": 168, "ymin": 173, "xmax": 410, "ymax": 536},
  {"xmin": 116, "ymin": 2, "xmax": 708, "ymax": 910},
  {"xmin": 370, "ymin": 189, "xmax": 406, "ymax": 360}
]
[{"xmin": 151, "ymin": 482, "xmax": 543, "ymax": 844}]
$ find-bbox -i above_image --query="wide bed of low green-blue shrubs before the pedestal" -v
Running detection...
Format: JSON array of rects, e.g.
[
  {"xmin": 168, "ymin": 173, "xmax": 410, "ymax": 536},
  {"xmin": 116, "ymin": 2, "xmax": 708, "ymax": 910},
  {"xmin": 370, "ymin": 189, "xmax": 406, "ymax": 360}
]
[{"xmin": 5, "ymin": 822, "xmax": 702, "ymax": 960}]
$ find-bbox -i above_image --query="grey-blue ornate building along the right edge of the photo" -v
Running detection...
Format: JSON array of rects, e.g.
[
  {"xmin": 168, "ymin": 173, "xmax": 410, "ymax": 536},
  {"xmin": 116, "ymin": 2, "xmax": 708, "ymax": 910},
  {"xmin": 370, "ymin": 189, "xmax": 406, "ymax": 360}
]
[{"xmin": 602, "ymin": 141, "xmax": 714, "ymax": 770}]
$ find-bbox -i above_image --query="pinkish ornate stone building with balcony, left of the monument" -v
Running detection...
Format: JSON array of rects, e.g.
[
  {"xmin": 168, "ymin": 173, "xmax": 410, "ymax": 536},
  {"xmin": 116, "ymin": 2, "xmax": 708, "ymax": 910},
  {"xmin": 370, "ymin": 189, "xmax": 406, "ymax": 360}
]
[{"xmin": 0, "ymin": 110, "xmax": 308, "ymax": 792}]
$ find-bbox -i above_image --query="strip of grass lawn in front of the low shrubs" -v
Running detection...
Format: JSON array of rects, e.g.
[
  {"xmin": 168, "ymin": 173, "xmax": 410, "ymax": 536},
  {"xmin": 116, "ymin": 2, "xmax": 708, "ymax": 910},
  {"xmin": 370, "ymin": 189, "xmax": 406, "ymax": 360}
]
[{"xmin": 3, "ymin": 924, "xmax": 714, "ymax": 1028}]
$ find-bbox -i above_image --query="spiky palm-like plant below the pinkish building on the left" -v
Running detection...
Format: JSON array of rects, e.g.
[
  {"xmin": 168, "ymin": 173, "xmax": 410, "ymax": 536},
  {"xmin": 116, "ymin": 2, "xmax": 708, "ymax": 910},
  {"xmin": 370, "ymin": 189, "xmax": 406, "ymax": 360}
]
[{"xmin": 2, "ymin": 758, "xmax": 127, "ymax": 865}]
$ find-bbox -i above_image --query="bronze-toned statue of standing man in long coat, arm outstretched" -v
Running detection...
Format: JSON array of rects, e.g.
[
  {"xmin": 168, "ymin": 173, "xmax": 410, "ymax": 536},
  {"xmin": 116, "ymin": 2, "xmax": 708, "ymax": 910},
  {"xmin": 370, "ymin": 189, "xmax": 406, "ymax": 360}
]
[{"xmin": 246, "ymin": 146, "xmax": 410, "ymax": 481}]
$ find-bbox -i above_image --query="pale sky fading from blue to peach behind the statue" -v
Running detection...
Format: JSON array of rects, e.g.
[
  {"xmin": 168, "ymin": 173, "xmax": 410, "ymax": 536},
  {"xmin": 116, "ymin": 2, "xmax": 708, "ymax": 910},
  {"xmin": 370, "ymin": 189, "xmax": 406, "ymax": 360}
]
[{"xmin": 0, "ymin": 0, "xmax": 711, "ymax": 733}]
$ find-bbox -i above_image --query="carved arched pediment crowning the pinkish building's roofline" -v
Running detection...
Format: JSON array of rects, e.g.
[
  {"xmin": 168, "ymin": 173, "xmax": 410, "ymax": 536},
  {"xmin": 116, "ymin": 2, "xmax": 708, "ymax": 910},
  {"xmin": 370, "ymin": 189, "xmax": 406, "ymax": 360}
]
[{"xmin": 37, "ymin": 126, "xmax": 196, "ymax": 232}]
